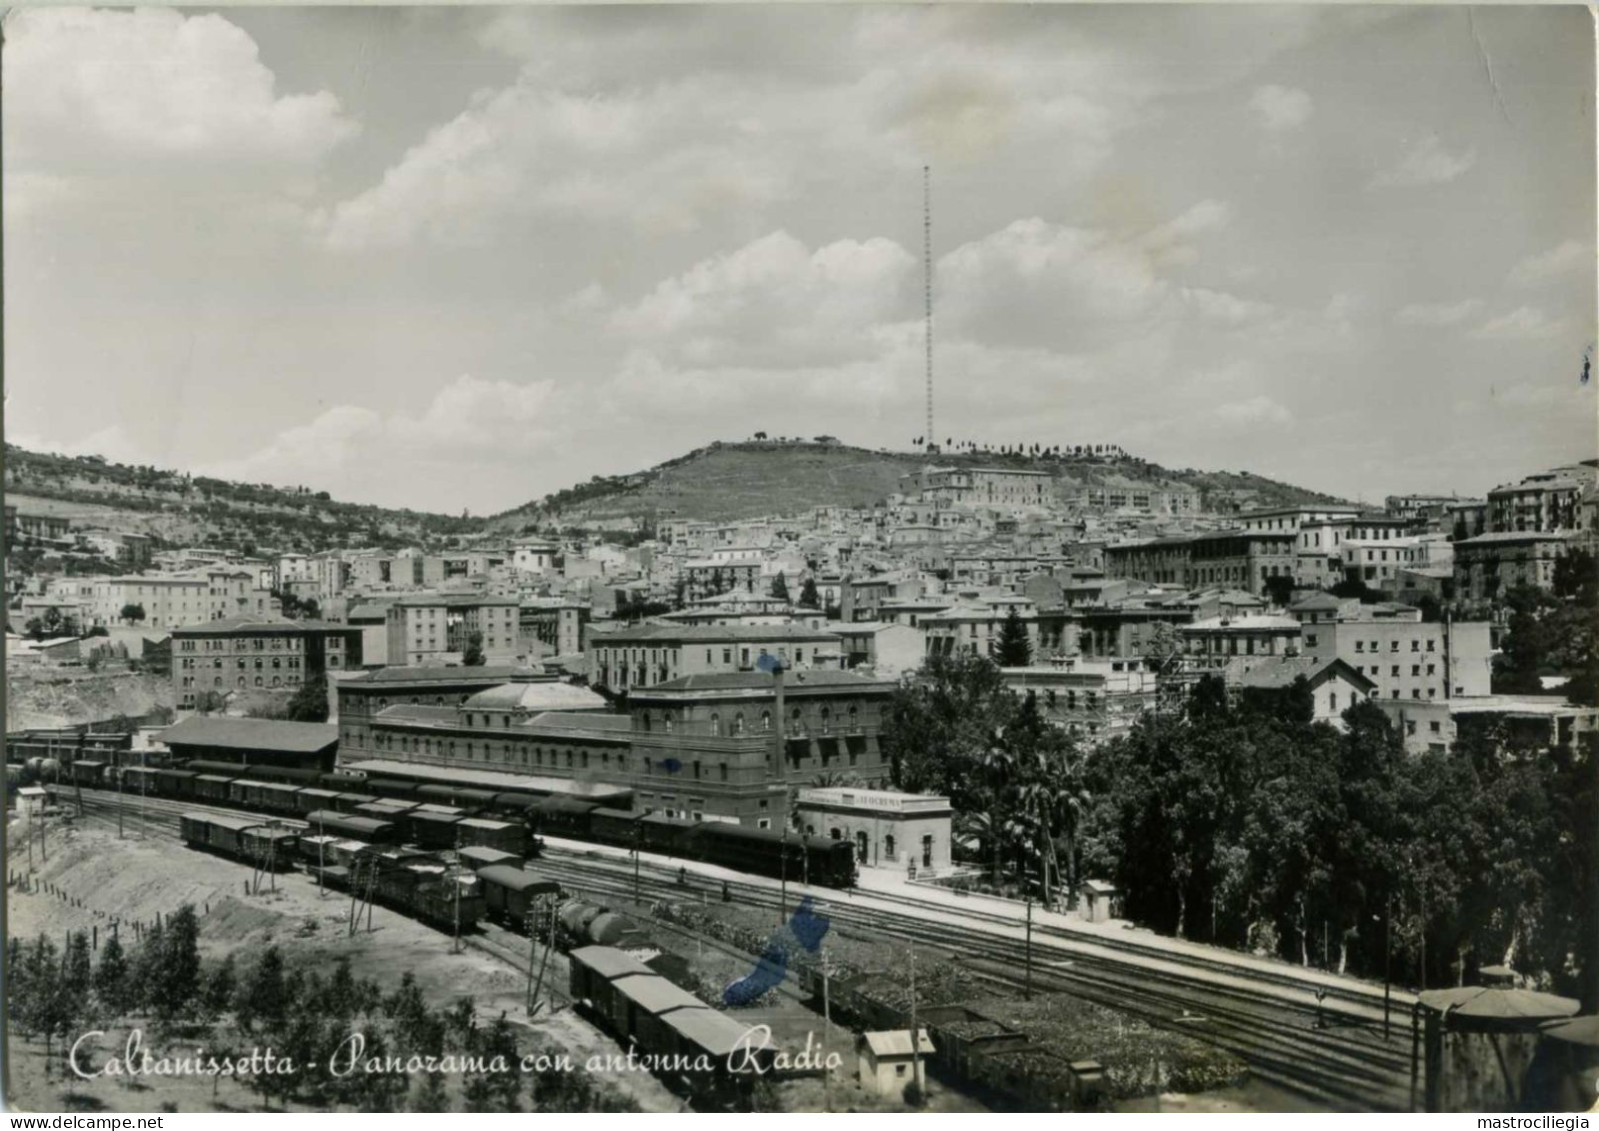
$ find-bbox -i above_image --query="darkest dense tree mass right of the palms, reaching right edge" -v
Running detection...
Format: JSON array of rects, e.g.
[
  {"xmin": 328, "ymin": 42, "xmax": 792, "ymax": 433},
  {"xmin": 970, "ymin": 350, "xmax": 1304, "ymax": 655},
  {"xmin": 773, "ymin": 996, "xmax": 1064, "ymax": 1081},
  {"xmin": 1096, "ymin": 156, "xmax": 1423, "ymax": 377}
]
[{"xmin": 1083, "ymin": 680, "xmax": 1599, "ymax": 990}]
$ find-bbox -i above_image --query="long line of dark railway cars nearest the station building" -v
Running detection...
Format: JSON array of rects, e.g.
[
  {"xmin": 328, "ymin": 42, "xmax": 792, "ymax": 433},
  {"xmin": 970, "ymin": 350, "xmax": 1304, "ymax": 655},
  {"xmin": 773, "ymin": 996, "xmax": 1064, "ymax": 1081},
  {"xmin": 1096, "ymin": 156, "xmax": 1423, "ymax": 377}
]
[{"xmin": 74, "ymin": 760, "xmax": 855, "ymax": 888}]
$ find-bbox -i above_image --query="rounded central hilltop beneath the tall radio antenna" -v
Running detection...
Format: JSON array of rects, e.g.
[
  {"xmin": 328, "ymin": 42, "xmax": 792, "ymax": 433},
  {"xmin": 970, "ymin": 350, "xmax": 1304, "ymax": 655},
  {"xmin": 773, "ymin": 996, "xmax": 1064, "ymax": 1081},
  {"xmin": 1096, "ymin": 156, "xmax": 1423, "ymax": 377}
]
[{"xmin": 489, "ymin": 442, "xmax": 1340, "ymax": 534}]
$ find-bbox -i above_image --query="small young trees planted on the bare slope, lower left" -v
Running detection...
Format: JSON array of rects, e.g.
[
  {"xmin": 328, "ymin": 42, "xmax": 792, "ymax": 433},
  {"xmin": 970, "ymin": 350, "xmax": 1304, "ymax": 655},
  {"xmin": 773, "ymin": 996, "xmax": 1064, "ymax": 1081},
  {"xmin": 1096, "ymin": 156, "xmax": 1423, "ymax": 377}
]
[{"xmin": 6, "ymin": 905, "xmax": 625, "ymax": 1112}]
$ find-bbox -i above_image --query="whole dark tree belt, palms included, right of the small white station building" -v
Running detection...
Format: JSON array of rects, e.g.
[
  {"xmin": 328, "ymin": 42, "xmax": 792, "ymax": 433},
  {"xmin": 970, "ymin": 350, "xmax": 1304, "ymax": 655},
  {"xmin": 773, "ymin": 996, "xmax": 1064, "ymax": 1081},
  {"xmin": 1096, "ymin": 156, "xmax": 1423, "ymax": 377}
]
[{"xmin": 883, "ymin": 656, "xmax": 1599, "ymax": 992}]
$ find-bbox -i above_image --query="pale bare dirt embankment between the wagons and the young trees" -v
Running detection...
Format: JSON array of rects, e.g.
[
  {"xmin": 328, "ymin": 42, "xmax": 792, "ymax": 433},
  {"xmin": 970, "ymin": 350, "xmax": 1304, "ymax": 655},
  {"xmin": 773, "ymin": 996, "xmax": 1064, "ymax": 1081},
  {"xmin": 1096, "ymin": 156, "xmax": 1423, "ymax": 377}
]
[{"xmin": 6, "ymin": 817, "xmax": 681, "ymax": 1112}]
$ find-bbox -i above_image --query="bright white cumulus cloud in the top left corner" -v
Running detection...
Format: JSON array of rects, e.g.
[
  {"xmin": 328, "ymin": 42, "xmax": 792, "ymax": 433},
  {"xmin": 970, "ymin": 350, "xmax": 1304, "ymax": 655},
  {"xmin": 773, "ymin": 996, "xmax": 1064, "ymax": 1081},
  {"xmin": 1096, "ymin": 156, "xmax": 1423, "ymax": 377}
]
[{"xmin": 5, "ymin": 8, "xmax": 358, "ymax": 168}]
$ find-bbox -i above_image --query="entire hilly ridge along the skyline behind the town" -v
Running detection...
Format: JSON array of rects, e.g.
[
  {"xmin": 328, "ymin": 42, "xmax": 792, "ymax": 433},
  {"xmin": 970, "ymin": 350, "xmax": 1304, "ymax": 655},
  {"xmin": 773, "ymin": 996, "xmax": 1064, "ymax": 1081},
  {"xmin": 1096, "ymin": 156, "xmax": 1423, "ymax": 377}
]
[{"xmin": 5, "ymin": 437, "xmax": 1343, "ymax": 554}]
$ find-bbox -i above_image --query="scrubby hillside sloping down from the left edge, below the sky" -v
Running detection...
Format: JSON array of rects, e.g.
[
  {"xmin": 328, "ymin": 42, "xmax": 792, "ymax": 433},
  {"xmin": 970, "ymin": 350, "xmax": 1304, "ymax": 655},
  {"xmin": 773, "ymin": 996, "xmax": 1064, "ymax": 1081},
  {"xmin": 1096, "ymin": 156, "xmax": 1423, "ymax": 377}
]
[{"xmin": 5, "ymin": 443, "xmax": 481, "ymax": 554}]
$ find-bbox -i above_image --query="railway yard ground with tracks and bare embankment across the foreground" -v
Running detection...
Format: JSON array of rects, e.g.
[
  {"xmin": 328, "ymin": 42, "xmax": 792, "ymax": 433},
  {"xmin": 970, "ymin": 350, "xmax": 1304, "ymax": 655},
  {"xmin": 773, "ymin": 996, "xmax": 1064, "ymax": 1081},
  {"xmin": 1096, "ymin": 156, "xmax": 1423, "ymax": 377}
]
[{"xmin": 10, "ymin": 787, "xmax": 1412, "ymax": 1110}]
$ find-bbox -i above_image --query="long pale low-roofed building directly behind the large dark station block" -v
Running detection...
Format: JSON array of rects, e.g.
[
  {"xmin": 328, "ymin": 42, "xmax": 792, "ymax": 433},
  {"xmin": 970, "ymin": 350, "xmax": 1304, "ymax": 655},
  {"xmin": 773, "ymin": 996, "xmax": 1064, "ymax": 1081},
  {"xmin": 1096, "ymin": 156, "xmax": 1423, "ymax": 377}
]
[{"xmin": 588, "ymin": 624, "xmax": 839, "ymax": 694}]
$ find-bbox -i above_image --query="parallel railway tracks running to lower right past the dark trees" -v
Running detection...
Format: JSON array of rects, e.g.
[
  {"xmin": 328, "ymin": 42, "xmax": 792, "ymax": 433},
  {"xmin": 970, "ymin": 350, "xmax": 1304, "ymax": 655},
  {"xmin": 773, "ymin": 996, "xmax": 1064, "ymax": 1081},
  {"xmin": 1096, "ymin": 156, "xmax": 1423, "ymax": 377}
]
[{"xmin": 62, "ymin": 789, "xmax": 1412, "ymax": 1110}]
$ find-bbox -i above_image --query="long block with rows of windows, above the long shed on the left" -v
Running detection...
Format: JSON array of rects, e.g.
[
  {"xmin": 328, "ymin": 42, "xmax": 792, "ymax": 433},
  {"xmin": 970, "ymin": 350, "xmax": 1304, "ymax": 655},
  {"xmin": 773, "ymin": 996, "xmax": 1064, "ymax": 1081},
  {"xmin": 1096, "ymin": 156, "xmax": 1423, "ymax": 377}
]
[{"xmin": 173, "ymin": 617, "xmax": 363, "ymax": 710}]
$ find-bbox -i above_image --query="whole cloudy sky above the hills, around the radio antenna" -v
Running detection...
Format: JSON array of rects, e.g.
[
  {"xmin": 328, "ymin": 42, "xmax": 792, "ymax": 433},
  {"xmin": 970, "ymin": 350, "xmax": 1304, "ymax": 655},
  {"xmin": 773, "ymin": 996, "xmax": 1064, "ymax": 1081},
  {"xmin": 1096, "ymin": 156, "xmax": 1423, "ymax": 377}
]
[{"xmin": 3, "ymin": 6, "xmax": 1599, "ymax": 514}]
